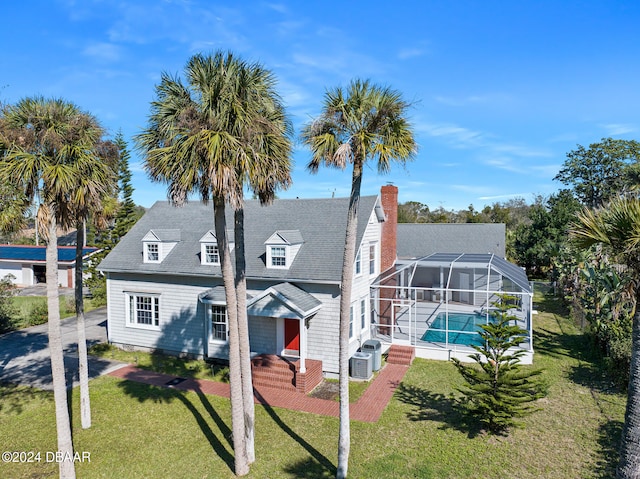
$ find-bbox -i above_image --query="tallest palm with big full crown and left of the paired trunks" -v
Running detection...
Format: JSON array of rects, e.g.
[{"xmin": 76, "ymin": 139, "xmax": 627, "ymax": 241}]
[{"xmin": 136, "ymin": 52, "xmax": 288, "ymax": 475}]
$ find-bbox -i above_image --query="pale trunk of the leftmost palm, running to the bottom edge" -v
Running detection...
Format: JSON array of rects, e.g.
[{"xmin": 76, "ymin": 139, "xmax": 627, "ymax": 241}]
[{"xmin": 46, "ymin": 215, "xmax": 76, "ymax": 479}]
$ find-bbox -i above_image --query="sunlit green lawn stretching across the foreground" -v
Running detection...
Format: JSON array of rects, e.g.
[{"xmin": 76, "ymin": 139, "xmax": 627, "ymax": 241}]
[{"xmin": 0, "ymin": 292, "xmax": 625, "ymax": 479}]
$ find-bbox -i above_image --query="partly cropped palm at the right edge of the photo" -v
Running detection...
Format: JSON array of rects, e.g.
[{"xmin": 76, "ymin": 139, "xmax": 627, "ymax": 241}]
[{"xmin": 571, "ymin": 197, "xmax": 640, "ymax": 479}]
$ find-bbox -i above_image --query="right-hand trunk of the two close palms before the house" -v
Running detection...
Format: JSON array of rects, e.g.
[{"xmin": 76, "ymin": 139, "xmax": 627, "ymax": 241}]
[{"xmin": 233, "ymin": 203, "xmax": 256, "ymax": 464}]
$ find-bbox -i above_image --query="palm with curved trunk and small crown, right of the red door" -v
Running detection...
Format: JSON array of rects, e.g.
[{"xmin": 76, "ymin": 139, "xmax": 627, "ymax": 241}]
[{"xmin": 302, "ymin": 80, "xmax": 417, "ymax": 478}]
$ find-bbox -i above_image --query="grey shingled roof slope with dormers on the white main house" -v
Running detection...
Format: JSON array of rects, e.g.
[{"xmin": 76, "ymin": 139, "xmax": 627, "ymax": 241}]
[{"xmin": 100, "ymin": 196, "xmax": 379, "ymax": 283}]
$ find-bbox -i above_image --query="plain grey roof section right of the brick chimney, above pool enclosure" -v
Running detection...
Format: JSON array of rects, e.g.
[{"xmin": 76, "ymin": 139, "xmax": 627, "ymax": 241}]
[{"xmin": 397, "ymin": 223, "xmax": 506, "ymax": 259}]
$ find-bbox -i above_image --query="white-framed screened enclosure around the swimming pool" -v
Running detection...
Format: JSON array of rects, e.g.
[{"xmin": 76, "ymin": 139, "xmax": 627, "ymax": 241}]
[{"xmin": 371, "ymin": 253, "xmax": 533, "ymax": 363}]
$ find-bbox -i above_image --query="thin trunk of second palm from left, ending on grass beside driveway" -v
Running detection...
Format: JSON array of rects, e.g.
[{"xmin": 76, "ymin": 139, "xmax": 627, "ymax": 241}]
[{"xmin": 75, "ymin": 221, "xmax": 91, "ymax": 429}]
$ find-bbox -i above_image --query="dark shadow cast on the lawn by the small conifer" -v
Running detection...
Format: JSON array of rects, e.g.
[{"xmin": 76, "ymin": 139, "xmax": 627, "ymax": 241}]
[{"xmin": 395, "ymin": 383, "xmax": 482, "ymax": 438}]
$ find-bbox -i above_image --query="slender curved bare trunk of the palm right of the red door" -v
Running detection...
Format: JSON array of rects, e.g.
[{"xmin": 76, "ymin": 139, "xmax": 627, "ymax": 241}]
[{"xmin": 336, "ymin": 160, "xmax": 362, "ymax": 479}]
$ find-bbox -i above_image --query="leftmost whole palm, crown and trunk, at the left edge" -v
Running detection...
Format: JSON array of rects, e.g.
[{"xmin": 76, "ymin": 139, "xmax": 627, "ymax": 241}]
[{"xmin": 0, "ymin": 97, "xmax": 112, "ymax": 478}]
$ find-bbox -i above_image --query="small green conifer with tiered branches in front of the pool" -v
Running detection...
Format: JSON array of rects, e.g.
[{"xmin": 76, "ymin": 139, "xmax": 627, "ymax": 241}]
[{"xmin": 453, "ymin": 296, "xmax": 546, "ymax": 434}]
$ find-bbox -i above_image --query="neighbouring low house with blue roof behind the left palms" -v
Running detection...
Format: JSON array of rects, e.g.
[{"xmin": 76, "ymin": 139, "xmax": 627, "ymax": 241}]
[{"xmin": 0, "ymin": 245, "xmax": 97, "ymax": 288}]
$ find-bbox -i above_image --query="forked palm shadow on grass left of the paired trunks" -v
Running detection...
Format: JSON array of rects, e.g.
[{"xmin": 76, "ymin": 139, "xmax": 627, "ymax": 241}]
[{"xmin": 118, "ymin": 380, "xmax": 234, "ymax": 472}]
